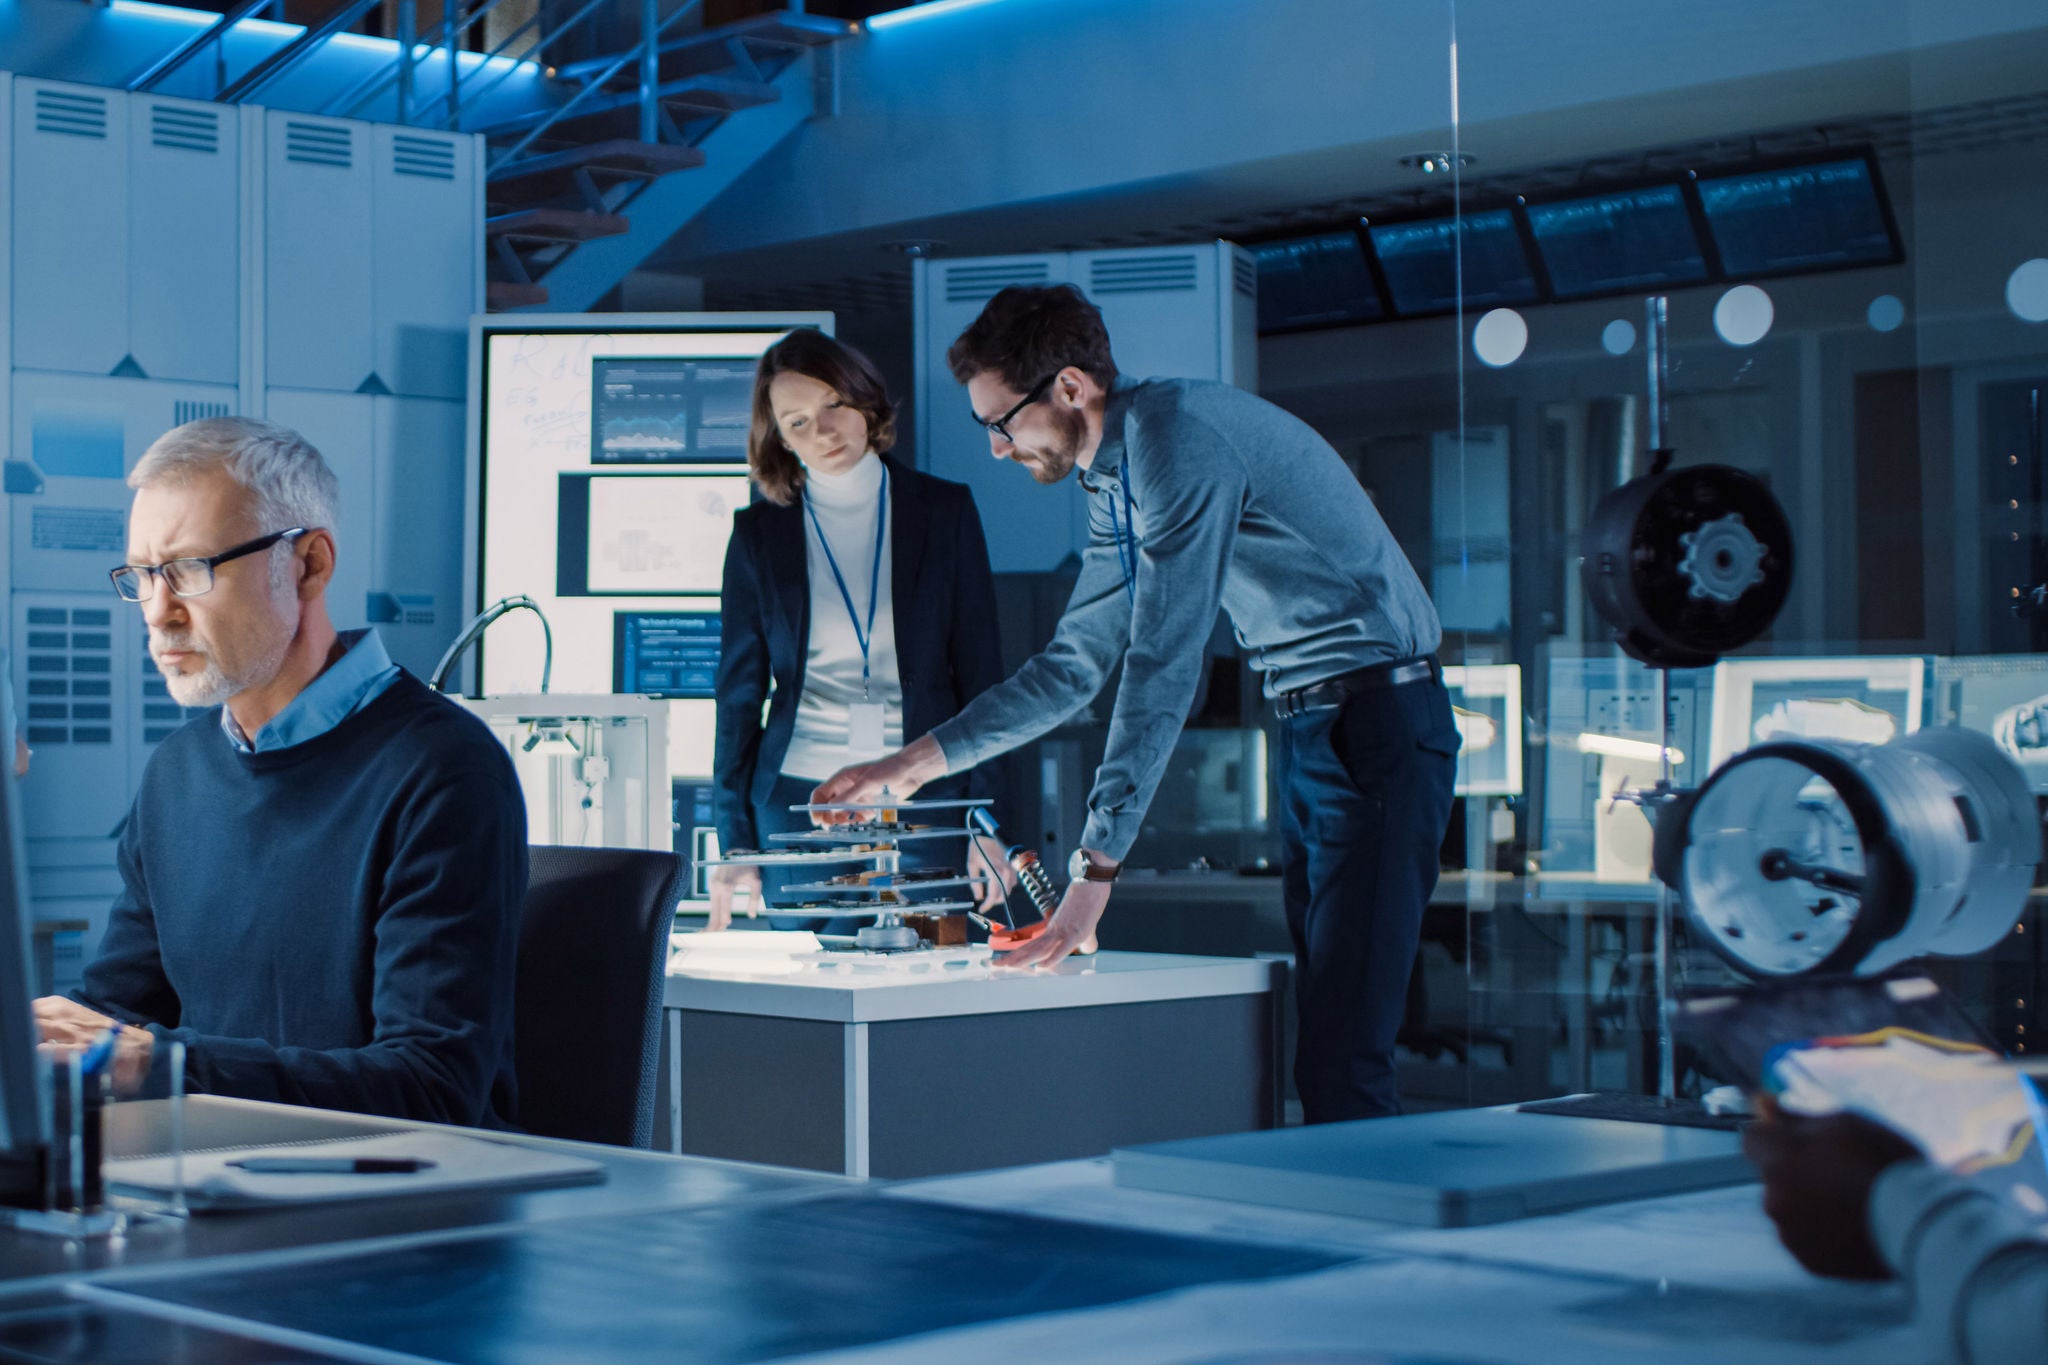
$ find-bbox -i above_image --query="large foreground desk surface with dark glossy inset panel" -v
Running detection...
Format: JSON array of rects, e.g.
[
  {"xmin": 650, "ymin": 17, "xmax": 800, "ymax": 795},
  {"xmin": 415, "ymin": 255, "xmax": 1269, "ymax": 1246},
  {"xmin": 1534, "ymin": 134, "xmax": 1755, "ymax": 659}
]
[{"xmin": 0, "ymin": 1115, "xmax": 1935, "ymax": 1365}]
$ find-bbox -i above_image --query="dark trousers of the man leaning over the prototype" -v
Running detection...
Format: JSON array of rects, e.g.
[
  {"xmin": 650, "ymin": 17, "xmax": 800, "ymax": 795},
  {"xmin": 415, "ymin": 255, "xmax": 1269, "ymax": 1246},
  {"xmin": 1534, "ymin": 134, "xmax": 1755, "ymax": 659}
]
[{"xmin": 1278, "ymin": 677, "xmax": 1458, "ymax": 1124}]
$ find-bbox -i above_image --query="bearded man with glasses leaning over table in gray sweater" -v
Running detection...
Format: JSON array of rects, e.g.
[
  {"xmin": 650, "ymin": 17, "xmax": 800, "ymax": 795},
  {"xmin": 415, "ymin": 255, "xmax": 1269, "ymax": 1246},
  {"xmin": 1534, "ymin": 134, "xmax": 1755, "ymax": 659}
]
[{"xmin": 815, "ymin": 284, "xmax": 1458, "ymax": 1124}]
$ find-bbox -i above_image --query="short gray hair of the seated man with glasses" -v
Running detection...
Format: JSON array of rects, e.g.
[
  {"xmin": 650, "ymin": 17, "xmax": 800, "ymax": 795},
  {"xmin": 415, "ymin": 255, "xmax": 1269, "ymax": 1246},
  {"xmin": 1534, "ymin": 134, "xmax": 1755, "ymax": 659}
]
[{"xmin": 129, "ymin": 417, "xmax": 340, "ymax": 534}]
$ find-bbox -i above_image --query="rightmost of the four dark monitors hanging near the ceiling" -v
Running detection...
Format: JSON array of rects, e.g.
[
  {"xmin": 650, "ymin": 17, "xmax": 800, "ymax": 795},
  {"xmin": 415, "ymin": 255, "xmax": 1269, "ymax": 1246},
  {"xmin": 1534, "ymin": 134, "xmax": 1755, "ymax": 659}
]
[{"xmin": 1700, "ymin": 156, "xmax": 1898, "ymax": 276}]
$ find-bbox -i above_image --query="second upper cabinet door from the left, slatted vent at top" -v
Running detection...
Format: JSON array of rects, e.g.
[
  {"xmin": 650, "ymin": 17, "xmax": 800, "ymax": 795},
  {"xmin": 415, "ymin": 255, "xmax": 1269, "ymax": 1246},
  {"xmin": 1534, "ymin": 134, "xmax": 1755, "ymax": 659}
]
[{"xmin": 127, "ymin": 96, "xmax": 242, "ymax": 385}]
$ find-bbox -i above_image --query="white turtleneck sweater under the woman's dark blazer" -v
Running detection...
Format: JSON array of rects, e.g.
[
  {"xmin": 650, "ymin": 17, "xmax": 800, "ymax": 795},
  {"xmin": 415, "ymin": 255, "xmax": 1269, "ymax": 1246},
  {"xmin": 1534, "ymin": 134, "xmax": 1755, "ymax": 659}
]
[{"xmin": 782, "ymin": 450, "xmax": 903, "ymax": 782}]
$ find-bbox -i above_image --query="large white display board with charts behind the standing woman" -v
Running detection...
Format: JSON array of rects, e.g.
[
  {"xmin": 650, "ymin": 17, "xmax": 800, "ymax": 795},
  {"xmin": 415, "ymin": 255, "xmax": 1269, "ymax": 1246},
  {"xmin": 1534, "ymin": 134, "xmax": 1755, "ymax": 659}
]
[{"xmin": 467, "ymin": 313, "xmax": 831, "ymax": 780}]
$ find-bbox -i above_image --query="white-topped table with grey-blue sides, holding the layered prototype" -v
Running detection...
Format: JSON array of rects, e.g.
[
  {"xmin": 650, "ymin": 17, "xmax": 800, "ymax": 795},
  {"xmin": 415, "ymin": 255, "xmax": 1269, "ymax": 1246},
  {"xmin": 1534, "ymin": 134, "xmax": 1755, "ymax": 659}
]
[{"xmin": 666, "ymin": 952, "xmax": 1284, "ymax": 1177}]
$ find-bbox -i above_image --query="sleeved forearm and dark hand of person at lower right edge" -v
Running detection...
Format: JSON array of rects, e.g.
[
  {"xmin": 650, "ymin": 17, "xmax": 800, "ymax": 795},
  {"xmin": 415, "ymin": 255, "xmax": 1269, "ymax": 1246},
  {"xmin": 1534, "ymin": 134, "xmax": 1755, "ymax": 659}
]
[{"xmin": 1743, "ymin": 1109, "xmax": 2048, "ymax": 1365}]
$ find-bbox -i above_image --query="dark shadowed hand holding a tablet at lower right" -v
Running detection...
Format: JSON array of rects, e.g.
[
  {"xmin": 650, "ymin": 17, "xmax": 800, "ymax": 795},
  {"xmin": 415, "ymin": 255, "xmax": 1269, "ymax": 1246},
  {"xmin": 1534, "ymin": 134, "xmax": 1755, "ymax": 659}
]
[{"xmin": 1743, "ymin": 1097, "xmax": 1919, "ymax": 1279}]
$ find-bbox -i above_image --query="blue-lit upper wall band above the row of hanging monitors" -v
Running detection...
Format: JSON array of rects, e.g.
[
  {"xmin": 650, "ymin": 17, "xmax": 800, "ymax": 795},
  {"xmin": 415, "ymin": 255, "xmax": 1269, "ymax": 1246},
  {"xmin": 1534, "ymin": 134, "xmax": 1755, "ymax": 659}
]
[{"xmin": 668, "ymin": 0, "xmax": 2048, "ymax": 260}]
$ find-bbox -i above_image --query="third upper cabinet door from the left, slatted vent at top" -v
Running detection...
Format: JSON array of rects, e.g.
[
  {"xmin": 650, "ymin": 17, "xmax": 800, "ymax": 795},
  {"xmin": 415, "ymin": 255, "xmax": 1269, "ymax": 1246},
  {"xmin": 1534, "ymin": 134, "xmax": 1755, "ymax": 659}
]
[{"xmin": 262, "ymin": 111, "xmax": 377, "ymax": 392}]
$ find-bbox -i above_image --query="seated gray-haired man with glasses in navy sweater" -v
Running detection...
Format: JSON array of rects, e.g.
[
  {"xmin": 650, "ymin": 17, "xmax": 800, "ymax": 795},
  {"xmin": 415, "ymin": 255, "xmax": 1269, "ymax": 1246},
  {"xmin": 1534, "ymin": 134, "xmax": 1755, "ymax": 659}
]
[{"xmin": 35, "ymin": 417, "xmax": 526, "ymax": 1126}]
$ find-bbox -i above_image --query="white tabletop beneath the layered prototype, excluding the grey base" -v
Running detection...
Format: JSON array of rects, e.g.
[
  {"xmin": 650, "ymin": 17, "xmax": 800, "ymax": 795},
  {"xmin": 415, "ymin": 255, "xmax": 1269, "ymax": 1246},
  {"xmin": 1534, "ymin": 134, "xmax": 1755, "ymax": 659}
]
[{"xmin": 664, "ymin": 952, "xmax": 1280, "ymax": 1023}]
